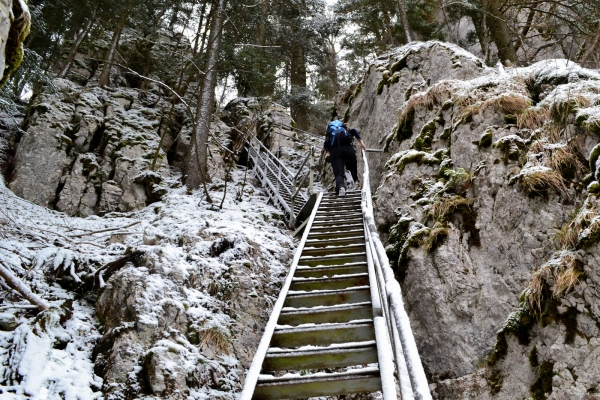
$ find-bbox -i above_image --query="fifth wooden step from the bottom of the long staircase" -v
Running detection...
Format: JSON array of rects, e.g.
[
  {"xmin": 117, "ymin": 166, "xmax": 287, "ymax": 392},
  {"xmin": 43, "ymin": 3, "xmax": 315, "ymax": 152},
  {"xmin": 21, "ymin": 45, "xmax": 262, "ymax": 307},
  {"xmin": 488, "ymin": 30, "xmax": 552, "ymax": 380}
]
[{"xmin": 283, "ymin": 286, "xmax": 371, "ymax": 308}]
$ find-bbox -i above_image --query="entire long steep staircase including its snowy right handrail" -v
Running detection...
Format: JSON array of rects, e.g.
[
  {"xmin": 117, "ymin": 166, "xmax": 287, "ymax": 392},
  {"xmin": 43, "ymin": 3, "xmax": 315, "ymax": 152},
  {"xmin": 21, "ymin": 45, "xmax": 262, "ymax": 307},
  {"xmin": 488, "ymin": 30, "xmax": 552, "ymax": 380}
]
[{"xmin": 240, "ymin": 148, "xmax": 431, "ymax": 400}]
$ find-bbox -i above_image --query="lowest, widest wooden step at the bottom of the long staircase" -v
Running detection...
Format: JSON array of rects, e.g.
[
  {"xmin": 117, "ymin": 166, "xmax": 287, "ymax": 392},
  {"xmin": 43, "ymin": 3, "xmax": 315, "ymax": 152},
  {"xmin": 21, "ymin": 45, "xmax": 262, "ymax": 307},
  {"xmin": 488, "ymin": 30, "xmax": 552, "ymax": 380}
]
[{"xmin": 252, "ymin": 369, "xmax": 381, "ymax": 400}]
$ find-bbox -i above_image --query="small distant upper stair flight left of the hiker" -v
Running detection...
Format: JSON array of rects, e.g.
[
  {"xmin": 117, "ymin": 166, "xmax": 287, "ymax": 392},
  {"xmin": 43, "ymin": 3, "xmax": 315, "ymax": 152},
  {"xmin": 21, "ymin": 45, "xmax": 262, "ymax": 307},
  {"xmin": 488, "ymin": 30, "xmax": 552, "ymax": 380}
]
[{"xmin": 248, "ymin": 139, "xmax": 310, "ymax": 220}]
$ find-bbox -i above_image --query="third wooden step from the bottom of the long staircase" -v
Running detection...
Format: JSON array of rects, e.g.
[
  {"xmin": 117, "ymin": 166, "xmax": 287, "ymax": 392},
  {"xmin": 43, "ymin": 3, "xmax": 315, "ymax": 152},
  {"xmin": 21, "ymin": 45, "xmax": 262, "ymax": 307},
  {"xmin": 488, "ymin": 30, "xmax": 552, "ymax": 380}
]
[{"xmin": 270, "ymin": 323, "xmax": 375, "ymax": 348}]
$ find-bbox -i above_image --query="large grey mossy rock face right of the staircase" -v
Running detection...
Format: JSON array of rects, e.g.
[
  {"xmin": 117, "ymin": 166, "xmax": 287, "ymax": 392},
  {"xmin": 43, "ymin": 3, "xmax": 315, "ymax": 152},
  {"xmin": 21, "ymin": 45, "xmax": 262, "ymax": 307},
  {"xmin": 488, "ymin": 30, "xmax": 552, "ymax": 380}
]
[{"xmin": 338, "ymin": 42, "xmax": 600, "ymax": 399}]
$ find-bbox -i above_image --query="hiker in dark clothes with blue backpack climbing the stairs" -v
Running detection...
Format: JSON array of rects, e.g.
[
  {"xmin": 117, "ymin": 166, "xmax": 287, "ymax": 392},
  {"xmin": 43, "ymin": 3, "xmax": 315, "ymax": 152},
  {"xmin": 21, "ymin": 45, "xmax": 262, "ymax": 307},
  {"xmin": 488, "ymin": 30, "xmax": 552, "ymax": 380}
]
[{"xmin": 323, "ymin": 119, "xmax": 367, "ymax": 196}]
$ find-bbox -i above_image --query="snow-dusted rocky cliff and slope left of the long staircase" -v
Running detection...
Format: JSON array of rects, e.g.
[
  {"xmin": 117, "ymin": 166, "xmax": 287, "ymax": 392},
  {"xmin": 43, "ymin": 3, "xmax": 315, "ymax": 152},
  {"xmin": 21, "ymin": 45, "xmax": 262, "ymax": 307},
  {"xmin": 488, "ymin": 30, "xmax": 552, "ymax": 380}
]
[{"xmin": 0, "ymin": 27, "xmax": 302, "ymax": 399}]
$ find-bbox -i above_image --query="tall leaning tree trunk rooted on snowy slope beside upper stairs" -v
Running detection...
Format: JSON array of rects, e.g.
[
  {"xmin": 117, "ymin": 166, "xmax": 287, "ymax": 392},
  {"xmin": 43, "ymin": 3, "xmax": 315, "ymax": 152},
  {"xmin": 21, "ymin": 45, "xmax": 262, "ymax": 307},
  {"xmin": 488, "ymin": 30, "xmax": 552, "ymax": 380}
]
[{"xmin": 184, "ymin": 0, "xmax": 227, "ymax": 190}]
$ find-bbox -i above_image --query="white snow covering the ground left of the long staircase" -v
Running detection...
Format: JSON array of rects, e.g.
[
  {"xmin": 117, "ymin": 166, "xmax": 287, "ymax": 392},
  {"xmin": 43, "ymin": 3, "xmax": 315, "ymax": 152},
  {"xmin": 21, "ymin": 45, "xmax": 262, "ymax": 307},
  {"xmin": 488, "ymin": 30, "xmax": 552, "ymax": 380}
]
[{"xmin": 0, "ymin": 170, "xmax": 295, "ymax": 399}]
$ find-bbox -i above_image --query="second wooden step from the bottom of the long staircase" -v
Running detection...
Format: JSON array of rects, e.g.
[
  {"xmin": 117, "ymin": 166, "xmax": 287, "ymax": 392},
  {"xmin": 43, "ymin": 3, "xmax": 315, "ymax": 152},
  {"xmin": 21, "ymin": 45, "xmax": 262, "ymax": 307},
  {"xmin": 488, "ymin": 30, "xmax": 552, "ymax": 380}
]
[{"xmin": 263, "ymin": 342, "xmax": 377, "ymax": 371}]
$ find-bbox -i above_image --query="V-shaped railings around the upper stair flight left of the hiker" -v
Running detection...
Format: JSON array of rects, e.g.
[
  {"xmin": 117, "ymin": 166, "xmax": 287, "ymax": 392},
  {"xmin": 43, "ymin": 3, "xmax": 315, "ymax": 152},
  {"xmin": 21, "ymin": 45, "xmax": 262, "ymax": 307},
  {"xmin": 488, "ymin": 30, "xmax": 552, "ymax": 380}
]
[{"xmin": 247, "ymin": 136, "xmax": 315, "ymax": 228}]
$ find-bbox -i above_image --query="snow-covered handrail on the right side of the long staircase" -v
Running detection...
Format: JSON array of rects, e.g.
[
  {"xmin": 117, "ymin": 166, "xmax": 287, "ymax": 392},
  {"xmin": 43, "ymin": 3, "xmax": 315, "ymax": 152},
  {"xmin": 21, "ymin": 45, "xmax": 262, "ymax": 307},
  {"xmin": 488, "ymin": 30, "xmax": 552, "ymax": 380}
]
[{"xmin": 361, "ymin": 150, "xmax": 432, "ymax": 400}]
